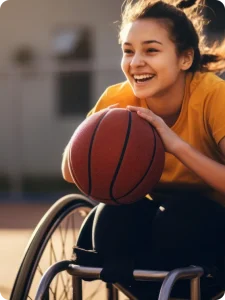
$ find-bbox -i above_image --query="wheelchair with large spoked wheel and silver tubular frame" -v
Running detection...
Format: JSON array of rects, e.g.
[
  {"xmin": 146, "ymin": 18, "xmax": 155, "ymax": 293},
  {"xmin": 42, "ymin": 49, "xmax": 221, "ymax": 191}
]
[{"xmin": 10, "ymin": 194, "xmax": 225, "ymax": 300}]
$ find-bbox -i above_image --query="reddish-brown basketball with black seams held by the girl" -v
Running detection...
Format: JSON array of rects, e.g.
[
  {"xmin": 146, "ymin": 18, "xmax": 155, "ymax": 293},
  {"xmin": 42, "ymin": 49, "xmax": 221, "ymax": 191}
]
[{"xmin": 69, "ymin": 108, "xmax": 165, "ymax": 204}]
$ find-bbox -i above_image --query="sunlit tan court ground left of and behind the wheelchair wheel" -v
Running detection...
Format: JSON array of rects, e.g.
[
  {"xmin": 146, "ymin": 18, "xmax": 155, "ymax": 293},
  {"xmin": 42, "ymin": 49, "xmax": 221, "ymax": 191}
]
[{"xmin": 0, "ymin": 203, "xmax": 127, "ymax": 300}]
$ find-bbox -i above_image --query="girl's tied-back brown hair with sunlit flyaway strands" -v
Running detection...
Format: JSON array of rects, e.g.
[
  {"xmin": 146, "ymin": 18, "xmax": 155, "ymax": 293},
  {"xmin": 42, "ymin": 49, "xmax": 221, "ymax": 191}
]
[{"xmin": 119, "ymin": 0, "xmax": 225, "ymax": 73}]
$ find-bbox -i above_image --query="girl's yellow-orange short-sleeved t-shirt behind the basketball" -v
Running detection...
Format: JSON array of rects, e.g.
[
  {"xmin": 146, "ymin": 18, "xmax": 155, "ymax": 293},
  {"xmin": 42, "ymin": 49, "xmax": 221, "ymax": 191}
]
[{"xmin": 88, "ymin": 72, "xmax": 225, "ymax": 204}]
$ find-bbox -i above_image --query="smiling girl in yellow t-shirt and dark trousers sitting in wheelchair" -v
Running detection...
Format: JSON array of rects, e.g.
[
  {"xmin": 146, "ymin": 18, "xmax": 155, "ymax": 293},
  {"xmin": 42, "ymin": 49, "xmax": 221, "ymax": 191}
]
[{"xmin": 62, "ymin": 0, "xmax": 225, "ymax": 299}]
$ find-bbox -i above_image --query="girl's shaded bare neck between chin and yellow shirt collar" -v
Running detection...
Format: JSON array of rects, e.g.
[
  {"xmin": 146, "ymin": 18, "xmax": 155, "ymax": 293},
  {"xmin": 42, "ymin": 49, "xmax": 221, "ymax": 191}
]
[{"xmin": 146, "ymin": 74, "xmax": 186, "ymax": 122}]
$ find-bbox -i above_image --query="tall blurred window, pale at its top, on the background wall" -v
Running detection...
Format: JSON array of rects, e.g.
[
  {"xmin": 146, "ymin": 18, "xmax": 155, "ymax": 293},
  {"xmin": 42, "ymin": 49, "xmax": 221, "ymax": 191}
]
[{"xmin": 53, "ymin": 27, "xmax": 93, "ymax": 117}]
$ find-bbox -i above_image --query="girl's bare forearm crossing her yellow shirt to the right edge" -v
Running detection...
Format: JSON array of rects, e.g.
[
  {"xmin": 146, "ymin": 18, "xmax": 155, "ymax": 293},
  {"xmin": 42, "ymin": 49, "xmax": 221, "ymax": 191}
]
[{"xmin": 174, "ymin": 142, "xmax": 225, "ymax": 195}]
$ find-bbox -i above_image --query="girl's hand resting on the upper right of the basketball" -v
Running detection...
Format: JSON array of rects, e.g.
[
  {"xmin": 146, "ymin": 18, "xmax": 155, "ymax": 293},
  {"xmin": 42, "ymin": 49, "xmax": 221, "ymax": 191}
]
[{"xmin": 127, "ymin": 106, "xmax": 185, "ymax": 155}]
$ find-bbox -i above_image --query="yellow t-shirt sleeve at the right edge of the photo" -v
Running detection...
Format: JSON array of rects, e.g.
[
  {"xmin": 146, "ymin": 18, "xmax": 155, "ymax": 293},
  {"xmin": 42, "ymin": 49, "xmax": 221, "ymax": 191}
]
[{"xmin": 205, "ymin": 81, "xmax": 225, "ymax": 144}]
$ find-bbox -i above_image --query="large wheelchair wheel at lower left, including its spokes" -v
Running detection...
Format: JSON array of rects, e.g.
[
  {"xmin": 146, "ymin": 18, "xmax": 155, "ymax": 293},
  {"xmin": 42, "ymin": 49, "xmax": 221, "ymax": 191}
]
[{"xmin": 10, "ymin": 194, "xmax": 108, "ymax": 300}]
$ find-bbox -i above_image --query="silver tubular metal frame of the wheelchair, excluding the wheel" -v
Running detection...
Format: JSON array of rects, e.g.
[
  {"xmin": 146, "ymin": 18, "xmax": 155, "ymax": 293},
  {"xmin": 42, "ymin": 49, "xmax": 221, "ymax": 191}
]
[{"xmin": 35, "ymin": 261, "xmax": 204, "ymax": 300}]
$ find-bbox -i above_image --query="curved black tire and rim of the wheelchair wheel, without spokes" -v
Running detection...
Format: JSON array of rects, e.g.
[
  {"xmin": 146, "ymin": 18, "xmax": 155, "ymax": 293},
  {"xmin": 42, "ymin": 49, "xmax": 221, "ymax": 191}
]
[{"xmin": 10, "ymin": 194, "xmax": 96, "ymax": 300}]
